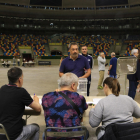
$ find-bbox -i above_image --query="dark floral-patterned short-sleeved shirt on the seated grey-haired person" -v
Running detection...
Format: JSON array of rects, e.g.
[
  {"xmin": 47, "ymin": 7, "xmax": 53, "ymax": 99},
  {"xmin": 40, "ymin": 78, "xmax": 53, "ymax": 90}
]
[{"xmin": 42, "ymin": 90, "xmax": 88, "ymax": 140}]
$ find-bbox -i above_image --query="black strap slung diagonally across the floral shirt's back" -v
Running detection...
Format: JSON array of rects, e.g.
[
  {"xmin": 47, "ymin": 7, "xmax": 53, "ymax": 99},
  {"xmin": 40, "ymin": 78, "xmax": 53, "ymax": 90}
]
[{"xmin": 59, "ymin": 92, "xmax": 83, "ymax": 120}]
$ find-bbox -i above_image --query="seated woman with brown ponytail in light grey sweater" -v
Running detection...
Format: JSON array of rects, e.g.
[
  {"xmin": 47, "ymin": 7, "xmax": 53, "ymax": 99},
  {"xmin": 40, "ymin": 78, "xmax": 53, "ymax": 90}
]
[{"xmin": 89, "ymin": 77, "xmax": 140, "ymax": 140}]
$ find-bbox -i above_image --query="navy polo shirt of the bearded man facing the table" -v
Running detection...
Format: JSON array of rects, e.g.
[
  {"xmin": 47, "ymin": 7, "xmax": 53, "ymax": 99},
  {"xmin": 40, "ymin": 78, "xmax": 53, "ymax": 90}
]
[{"xmin": 59, "ymin": 55, "xmax": 90, "ymax": 77}]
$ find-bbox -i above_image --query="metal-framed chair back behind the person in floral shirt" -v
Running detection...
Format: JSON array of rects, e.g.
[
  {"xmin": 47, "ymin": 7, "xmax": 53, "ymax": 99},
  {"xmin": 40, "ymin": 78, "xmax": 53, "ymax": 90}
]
[{"xmin": 44, "ymin": 126, "xmax": 87, "ymax": 140}]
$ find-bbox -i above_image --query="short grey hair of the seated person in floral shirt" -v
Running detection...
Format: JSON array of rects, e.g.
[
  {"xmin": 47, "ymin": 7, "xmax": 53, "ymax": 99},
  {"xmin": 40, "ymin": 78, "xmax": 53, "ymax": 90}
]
[{"xmin": 59, "ymin": 72, "xmax": 78, "ymax": 87}]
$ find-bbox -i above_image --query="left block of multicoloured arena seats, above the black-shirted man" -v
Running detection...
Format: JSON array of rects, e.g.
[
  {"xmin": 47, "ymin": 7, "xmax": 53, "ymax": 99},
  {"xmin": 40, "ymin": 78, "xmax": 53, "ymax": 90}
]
[{"xmin": 0, "ymin": 35, "xmax": 48, "ymax": 56}]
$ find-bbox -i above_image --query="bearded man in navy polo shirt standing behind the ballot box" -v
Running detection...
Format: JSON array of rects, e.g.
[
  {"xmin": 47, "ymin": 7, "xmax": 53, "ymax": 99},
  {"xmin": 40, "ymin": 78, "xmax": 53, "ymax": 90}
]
[{"xmin": 59, "ymin": 42, "xmax": 91, "ymax": 78}]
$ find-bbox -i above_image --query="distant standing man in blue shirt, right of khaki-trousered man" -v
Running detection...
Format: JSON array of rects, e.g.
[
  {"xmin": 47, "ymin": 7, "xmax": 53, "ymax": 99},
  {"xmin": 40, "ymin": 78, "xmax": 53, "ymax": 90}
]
[{"xmin": 108, "ymin": 52, "xmax": 117, "ymax": 78}]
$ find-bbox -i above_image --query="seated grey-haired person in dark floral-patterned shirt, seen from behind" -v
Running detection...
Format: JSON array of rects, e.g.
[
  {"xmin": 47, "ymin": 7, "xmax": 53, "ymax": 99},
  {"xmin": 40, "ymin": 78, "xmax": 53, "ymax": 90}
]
[{"xmin": 42, "ymin": 73, "xmax": 88, "ymax": 140}]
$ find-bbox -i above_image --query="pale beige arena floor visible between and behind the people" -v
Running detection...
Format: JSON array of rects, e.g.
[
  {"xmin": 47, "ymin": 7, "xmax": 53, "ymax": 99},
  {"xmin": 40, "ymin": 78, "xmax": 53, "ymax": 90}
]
[{"xmin": 0, "ymin": 66, "xmax": 140, "ymax": 140}]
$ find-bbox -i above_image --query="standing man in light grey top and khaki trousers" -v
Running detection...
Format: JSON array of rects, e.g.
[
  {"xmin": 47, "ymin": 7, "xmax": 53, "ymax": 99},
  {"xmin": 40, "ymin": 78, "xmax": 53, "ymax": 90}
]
[{"xmin": 97, "ymin": 52, "xmax": 106, "ymax": 89}]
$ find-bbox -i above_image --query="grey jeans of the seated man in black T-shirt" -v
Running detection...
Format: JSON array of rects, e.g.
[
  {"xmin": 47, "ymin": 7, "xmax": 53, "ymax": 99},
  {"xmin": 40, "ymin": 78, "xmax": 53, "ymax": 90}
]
[{"xmin": 16, "ymin": 124, "xmax": 40, "ymax": 140}]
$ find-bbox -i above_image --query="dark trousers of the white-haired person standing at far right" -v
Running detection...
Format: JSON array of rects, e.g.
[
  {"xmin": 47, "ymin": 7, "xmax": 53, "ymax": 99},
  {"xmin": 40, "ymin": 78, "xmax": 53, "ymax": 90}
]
[{"xmin": 128, "ymin": 80, "xmax": 138, "ymax": 99}]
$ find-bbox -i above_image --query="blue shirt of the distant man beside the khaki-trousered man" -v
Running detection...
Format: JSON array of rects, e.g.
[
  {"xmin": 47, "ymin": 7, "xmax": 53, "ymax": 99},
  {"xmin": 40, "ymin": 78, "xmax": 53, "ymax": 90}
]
[{"xmin": 110, "ymin": 57, "xmax": 117, "ymax": 75}]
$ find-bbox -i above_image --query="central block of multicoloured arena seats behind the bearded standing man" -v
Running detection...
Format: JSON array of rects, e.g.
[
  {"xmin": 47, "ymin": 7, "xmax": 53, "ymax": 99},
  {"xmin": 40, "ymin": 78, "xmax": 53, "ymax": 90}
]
[{"xmin": 55, "ymin": 36, "xmax": 115, "ymax": 55}]
